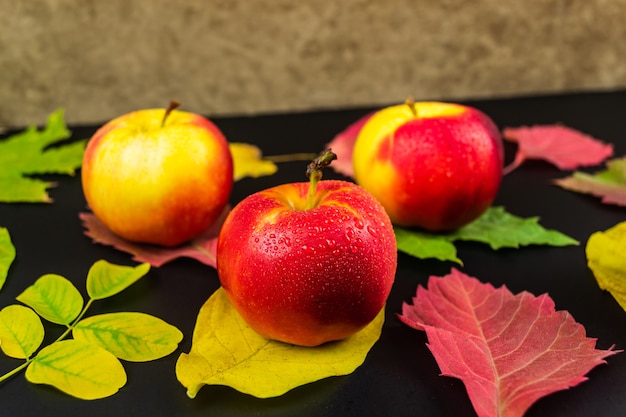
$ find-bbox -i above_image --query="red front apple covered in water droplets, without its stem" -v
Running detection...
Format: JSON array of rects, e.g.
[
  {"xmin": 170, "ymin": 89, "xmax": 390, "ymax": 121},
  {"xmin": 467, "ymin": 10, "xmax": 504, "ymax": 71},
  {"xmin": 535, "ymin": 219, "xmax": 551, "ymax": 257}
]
[{"xmin": 217, "ymin": 180, "xmax": 397, "ymax": 346}]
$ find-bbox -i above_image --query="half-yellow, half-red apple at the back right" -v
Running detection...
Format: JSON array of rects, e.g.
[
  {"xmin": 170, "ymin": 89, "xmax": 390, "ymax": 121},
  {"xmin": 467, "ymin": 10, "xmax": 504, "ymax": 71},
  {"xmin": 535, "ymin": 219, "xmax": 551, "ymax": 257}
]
[{"xmin": 352, "ymin": 102, "xmax": 504, "ymax": 231}]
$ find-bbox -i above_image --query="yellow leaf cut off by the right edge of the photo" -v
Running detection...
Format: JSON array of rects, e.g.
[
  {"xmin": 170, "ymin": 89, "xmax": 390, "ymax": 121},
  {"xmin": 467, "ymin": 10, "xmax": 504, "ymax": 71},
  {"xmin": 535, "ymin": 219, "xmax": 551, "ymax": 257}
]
[{"xmin": 585, "ymin": 222, "xmax": 626, "ymax": 310}]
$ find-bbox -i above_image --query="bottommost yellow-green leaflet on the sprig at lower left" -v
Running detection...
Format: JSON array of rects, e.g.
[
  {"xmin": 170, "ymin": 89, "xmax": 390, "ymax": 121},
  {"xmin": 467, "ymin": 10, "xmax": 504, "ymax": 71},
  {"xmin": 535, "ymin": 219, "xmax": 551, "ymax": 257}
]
[{"xmin": 26, "ymin": 340, "xmax": 126, "ymax": 400}]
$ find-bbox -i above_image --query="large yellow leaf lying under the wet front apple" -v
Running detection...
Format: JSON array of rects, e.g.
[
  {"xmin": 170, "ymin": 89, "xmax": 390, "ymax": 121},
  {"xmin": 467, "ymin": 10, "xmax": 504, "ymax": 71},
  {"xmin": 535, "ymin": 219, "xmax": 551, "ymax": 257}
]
[{"xmin": 176, "ymin": 288, "xmax": 384, "ymax": 398}]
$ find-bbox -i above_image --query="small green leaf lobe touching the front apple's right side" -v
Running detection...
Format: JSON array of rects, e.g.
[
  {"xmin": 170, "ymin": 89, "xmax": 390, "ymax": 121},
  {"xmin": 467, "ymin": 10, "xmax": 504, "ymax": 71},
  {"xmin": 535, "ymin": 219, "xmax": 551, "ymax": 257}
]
[{"xmin": 394, "ymin": 227, "xmax": 462, "ymax": 264}]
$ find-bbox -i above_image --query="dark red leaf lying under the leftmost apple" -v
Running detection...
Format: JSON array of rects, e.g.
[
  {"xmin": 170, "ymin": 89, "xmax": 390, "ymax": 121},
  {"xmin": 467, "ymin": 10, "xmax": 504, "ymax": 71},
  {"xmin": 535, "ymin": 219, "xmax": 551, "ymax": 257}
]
[{"xmin": 79, "ymin": 207, "xmax": 230, "ymax": 268}]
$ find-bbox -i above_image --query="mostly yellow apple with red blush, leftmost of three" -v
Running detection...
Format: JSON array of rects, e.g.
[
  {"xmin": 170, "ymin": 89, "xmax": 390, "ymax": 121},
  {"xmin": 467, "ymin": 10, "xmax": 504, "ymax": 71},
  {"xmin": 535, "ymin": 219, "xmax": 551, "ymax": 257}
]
[{"xmin": 81, "ymin": 109, "xmax": 233, "ymax": 246}]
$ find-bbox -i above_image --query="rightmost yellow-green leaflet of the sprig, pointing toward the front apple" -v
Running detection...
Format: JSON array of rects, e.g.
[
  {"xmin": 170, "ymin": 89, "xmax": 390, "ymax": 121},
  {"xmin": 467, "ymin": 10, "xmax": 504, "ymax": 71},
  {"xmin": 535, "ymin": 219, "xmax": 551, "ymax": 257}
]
[{"xmin": 72, "ymin": 313, "xmax": 183, "ymax": 362}]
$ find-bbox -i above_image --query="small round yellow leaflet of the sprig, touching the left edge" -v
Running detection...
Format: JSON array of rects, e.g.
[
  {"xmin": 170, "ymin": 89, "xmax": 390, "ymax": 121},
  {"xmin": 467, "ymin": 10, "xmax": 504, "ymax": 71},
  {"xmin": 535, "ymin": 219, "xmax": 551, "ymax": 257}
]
[{"xmin": 0, "ymin": 304, "xmax": 44, "ymax": 359}]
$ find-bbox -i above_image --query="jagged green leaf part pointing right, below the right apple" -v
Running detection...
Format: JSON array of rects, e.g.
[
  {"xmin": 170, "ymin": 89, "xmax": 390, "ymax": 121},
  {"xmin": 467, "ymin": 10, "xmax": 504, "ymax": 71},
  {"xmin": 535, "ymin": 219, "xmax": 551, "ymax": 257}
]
[{"xmin": 448, "ymin": 207, "xmax": 578, "ymax": 250}]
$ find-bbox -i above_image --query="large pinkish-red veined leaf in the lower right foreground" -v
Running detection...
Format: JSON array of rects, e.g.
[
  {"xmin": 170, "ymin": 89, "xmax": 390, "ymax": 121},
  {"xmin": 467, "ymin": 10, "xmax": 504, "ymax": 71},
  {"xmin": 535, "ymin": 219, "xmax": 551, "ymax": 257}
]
[{"xmin": 399, "ymin": 269, "xmax": 618, "ymax": 417}]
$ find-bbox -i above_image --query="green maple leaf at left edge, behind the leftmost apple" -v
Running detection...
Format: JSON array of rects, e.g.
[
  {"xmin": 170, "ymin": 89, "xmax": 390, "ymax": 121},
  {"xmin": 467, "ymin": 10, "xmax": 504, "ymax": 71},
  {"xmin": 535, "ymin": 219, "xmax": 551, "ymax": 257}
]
[{"xmin": 0, "ymin": 109, "xmax": 86, "ymax": 203}]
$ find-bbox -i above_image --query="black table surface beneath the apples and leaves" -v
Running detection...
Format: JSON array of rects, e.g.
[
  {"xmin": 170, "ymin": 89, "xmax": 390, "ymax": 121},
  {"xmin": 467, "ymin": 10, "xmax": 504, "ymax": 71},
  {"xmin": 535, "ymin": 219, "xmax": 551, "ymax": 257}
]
[{"xmin": 0, "ymin": 91, "xmax": 626, "ymax": 417}]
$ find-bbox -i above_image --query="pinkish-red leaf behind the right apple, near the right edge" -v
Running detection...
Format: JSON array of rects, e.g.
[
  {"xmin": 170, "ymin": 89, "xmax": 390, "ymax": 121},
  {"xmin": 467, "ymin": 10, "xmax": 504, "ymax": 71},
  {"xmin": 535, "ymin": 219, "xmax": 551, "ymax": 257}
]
[{"xmin": 502, "ymin": 125, "xmax": 613, "ymax": 174}]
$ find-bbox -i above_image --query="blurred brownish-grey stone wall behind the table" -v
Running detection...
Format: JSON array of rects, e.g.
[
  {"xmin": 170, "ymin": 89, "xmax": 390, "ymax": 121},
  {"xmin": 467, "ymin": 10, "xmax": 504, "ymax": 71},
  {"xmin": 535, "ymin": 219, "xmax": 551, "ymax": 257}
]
[{"xmin": 0, "ymin": 0, "xmax": 626, "ymax": 127}]
